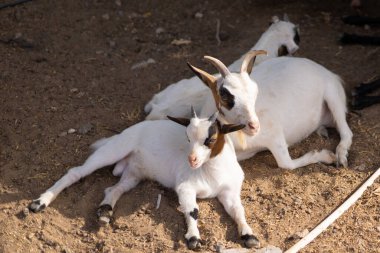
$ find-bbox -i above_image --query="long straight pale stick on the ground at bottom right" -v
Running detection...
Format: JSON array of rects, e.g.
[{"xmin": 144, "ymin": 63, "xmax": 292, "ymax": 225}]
[{"xmin": 285, "ymin": 168, "xmax": 380, "ymax": 253}]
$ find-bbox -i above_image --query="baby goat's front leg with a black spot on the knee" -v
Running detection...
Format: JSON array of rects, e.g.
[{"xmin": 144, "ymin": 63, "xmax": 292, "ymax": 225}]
[{"xmin": 176, "ymin": 185, "xmax": 201, "ymax": 250}]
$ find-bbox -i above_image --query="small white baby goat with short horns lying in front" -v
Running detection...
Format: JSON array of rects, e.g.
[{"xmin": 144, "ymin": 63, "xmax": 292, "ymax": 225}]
[{"xmin": 30, "ymin": 111, "xmax": 259, "ymax": 249}]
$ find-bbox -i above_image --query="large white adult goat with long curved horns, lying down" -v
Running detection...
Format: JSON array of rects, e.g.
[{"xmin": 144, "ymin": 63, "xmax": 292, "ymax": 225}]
[{"xmin": 143, "ymin": 51, "xmax": 352, "ymax": 169}]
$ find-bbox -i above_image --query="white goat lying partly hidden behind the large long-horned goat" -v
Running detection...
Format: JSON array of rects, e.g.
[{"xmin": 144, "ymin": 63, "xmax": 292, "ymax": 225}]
[{"xmin": 144, "ymin": 15, "xmax": 300, "ymax": 120}]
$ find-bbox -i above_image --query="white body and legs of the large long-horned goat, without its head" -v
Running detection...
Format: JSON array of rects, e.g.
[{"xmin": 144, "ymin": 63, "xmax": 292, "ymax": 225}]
[{"xmin": 235, "ymin": 57, "xmax": 352, "ymax": 169}]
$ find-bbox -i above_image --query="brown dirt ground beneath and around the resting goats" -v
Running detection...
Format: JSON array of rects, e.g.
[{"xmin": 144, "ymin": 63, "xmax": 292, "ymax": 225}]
[{"xmin": 0, "ymin": 0, "xmax": 380, "ymax": 253}]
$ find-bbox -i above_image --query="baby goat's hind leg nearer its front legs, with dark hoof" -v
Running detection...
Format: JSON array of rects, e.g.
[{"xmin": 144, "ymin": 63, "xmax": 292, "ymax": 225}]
[{"xmin": 97, "ymin": 169, "xmax": 141, "ymax": 224}]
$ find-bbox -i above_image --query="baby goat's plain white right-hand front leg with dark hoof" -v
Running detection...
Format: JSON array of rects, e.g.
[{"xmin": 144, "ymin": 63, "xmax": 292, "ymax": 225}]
[{"xmin": 218, "ymin": 189, "xmax": 260, "ymax": 248}]
